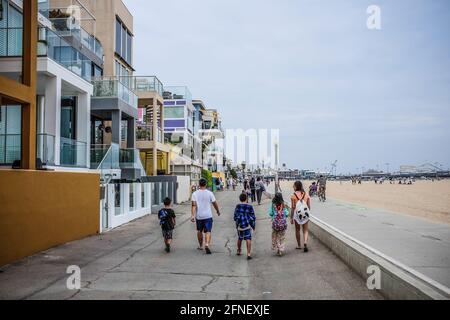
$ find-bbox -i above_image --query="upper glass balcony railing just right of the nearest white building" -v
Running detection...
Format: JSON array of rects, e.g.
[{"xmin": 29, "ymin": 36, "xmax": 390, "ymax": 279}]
[{"xmin": 92, "ymin": 77, "xmax": 138, "ymax": 109}]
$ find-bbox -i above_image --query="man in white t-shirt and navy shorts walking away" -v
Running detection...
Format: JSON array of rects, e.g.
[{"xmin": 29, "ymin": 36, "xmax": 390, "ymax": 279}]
[{"xmin": 191, "ymin": 179, "xmax": 220, "ymax": 254}]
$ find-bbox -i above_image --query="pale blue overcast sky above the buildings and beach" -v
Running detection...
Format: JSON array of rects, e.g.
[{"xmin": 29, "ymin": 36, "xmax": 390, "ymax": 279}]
[{"xmin": 124, "ymin": 0, "xmax": 450, "ymax": 173}]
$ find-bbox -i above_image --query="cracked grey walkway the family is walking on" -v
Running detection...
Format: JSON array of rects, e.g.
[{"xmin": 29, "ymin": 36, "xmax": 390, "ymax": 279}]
[{"xmin": 0, "ymin": 192, "xmax": 382, "ymax": 300}]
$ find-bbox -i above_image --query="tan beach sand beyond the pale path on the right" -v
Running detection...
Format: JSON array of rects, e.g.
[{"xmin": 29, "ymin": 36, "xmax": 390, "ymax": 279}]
[{"xmin": 281, "ymin": 180, "xmax": 450, "ymax": 225}]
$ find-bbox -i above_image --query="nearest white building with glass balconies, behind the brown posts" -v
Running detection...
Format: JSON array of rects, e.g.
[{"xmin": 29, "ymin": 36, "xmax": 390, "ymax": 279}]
[{"xmin": 0, "ymin": 0, "xmax": 103, "ymax": 172}]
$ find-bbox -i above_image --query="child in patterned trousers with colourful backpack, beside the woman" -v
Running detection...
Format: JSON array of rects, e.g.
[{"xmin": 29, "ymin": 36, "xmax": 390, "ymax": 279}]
[{"xmin": 269, "ymin": 193, "xmax": 289, "ymax": 257}]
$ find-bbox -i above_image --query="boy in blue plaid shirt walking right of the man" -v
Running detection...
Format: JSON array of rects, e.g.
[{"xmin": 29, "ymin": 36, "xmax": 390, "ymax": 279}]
[{"xmin": 234, "ymin": 193, "xmax": 256, "ymax": 260}]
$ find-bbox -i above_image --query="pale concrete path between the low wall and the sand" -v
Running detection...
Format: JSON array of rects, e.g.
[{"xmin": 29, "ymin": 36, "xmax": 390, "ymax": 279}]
[{"xmin": 283, "ymin": 185, "xmax": 450, "ymax": 287}]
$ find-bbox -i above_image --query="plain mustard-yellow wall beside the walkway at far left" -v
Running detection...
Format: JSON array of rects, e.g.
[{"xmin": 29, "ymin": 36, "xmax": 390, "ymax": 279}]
[{"xmin": 0, "ymin": 170, "xmax": 100, "ymax": 266}]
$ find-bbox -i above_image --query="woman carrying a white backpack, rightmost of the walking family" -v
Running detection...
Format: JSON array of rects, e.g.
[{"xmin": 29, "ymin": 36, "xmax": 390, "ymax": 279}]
[{"xmin": 291, "ymin": 181, "xmax": 311, "ymax": 252}]
